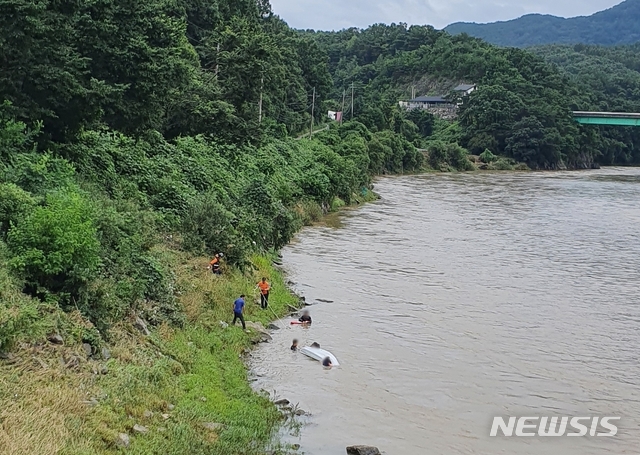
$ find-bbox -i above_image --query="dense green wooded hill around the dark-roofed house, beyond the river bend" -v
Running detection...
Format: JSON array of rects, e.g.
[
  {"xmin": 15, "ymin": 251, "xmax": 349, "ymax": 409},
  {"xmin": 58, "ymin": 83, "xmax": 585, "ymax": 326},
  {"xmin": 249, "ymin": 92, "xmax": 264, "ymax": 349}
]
[{"xmin": 307, "ymin": 24, "xmax": 640, "ymax": 169}]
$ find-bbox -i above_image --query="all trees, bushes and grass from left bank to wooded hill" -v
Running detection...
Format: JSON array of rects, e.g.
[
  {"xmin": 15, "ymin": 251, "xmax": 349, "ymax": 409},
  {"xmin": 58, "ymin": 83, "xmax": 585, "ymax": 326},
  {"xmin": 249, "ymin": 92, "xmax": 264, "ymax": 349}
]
[{"xmin": 0, "ymin": 0, "xmax": 636, "ymax": 454}]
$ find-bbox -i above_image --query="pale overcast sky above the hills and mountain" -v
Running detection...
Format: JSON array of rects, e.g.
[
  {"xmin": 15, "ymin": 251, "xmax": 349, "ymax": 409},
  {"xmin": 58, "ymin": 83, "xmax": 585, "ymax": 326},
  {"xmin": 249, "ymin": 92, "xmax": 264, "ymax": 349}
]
[{"xmin": 271, "ymin": 0, "xmax": 621, "ymax": 30}]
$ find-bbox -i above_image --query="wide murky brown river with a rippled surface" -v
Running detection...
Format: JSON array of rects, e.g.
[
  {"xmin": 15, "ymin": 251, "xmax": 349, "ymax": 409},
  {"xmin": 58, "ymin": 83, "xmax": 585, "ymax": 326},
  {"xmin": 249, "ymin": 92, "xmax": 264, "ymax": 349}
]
[{"xmin": 251, "ymin": 168, "xmax": 640, "ymax": 455}]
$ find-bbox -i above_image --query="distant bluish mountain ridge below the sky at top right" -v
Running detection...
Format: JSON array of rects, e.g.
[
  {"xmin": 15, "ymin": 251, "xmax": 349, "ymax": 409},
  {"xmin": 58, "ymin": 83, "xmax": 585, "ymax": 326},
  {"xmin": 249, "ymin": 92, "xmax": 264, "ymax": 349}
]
[{"xmin": 445, "ymin": 0, "xmax": 640, "ymax": 47}]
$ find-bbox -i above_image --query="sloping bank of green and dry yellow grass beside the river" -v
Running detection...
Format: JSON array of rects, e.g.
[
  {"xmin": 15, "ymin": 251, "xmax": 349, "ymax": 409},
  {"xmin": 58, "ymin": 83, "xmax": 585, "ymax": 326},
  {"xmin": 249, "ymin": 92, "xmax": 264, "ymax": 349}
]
[{"xmin": 0, "ymin": 253, "xmax": 298, "ymax": 455}]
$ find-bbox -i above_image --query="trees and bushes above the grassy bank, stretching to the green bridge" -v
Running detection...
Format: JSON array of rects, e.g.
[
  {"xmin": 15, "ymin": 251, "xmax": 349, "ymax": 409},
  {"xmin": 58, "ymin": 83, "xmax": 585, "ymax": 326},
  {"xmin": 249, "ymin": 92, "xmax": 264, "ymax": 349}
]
[{"xmin": 0, "ymin": 0, "xmax": 638, "ymax": 347}]
